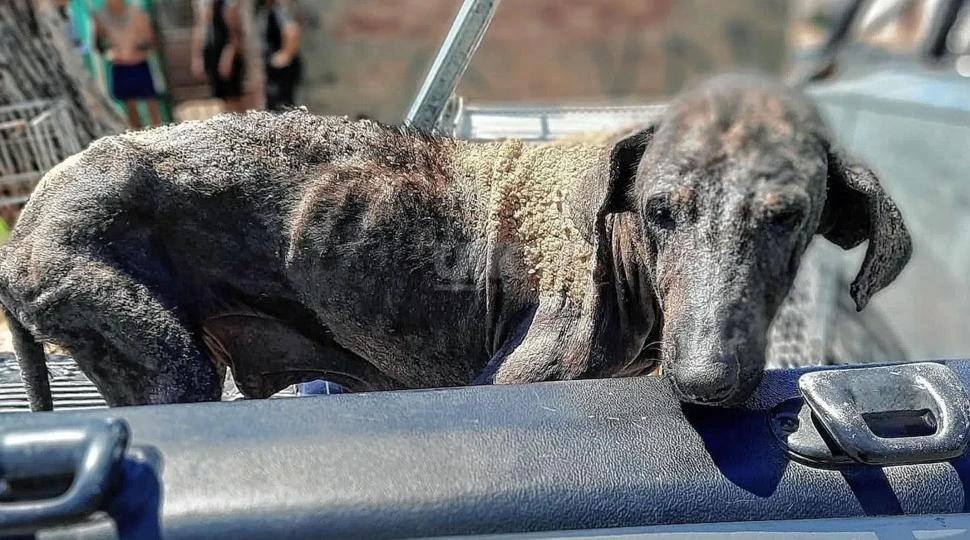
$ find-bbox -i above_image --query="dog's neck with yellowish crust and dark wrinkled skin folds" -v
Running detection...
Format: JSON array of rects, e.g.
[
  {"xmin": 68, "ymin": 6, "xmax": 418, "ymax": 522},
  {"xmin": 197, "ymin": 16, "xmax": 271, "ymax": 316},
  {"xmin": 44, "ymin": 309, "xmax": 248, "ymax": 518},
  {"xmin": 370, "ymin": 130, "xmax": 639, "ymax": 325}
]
[{"xmin": 455, "ymin": 140, "xmax": 658, "ymax": 376}]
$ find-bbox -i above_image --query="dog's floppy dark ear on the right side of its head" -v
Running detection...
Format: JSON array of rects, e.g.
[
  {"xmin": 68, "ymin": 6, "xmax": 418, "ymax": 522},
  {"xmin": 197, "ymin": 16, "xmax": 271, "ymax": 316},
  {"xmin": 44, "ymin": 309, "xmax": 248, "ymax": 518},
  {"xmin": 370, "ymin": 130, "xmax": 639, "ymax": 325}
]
[{"xmin": 818, "ymin": 149, "xmax": 913, "ymax": 311}]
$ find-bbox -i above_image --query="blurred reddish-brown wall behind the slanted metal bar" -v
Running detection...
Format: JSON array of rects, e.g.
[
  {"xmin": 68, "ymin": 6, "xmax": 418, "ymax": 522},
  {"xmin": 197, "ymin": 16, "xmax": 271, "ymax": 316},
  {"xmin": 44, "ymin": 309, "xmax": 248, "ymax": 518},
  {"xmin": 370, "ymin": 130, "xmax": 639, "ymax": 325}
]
[{"xmin": 155, "ymin": 0, "xmax": 793, "ymax": 122}]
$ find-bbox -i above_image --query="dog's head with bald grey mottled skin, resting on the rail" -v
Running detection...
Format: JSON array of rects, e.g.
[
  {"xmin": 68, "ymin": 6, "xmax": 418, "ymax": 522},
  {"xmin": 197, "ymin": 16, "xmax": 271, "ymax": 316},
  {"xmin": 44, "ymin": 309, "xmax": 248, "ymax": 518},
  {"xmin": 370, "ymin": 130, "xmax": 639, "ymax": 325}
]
[{"xmin": 599, "ymin": 76, "xmax": 911, "ymax": 405}]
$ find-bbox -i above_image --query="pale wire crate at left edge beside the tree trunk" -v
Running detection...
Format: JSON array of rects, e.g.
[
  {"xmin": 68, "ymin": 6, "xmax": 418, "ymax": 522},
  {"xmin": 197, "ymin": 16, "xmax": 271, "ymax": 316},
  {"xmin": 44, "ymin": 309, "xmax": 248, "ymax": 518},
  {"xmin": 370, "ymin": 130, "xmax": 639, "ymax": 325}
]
[{"xmin": 0, "ymin": 99, "xmax": 81, "ymax": 227}]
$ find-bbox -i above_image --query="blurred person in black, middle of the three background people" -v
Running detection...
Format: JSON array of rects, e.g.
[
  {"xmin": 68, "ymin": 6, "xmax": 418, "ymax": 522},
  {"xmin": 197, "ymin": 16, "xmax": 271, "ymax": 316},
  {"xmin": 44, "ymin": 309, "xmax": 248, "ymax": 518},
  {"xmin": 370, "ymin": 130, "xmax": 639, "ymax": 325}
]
[{"xmin": 192, "ymin": 0, "xmax": 245, "ymax": 112}]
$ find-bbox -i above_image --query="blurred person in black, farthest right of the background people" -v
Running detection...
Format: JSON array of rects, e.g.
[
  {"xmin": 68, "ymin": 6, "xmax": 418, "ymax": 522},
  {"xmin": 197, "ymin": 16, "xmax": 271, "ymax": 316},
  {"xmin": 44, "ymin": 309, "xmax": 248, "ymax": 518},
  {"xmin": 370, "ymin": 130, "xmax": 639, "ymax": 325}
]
[{"xmin": 260, "ymin": 0, "xmax": 303, "ymax": 111}]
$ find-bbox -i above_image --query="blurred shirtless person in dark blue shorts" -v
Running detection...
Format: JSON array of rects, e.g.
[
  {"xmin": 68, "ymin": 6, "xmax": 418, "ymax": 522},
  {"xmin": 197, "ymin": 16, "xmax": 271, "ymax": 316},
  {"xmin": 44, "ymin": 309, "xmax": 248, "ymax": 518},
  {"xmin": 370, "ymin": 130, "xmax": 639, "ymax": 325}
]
[{"xmin": 94, "ymin": 0, "xmax": 162, "ymax": 129}]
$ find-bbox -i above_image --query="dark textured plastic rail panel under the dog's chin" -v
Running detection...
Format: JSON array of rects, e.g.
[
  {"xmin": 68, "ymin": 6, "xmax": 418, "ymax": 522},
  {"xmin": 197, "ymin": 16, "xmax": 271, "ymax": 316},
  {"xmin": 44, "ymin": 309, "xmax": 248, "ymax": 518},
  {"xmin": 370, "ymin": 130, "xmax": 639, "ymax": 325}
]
[{"xmin": 0, "ymin": 362, "xmax": 970, "ymax": 540}]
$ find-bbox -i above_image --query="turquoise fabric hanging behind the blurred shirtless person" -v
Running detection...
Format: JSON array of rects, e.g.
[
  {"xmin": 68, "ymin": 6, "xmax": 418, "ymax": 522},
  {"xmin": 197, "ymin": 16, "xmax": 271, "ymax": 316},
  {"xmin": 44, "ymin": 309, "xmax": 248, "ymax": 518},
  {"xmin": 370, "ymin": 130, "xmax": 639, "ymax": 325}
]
[{"xmin": 70, "ymin": 0, "xmax": 172, "ymax": 125}]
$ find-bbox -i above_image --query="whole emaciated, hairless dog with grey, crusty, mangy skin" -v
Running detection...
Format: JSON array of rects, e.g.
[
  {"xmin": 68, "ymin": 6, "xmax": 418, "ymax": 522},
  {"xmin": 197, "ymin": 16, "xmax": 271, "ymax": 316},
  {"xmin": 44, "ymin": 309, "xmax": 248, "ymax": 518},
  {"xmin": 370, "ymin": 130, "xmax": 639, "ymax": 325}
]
[{"xmin": 0, "ymin": 76, "xmax": 911, "ymax": 410}]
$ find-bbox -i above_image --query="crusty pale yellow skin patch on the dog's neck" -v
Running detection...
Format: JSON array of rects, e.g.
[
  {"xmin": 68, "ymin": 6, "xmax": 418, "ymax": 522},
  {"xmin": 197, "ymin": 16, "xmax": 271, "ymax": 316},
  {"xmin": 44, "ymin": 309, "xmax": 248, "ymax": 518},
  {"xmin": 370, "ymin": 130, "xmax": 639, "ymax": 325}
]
[{"xmin": 456, "ymin": 140, "xmax": 607, "ymax": 304}]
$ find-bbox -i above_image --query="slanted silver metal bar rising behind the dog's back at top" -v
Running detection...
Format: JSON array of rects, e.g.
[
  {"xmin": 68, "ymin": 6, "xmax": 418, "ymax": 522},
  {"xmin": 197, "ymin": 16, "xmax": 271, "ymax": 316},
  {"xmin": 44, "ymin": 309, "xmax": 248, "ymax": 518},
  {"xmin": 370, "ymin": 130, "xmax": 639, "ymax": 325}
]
[{"xmin": 405, "ymin": 0, "xmax": 500, "ymax": 131}]
